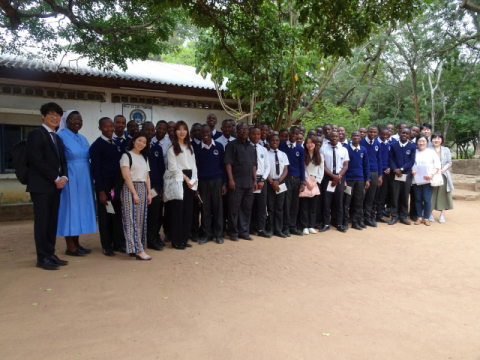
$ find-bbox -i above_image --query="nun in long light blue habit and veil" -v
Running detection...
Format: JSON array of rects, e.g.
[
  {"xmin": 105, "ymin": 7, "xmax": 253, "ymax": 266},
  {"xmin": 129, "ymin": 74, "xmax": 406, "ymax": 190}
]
[{"xmin": 57, "ymin": 110, "xmax": 97, "ymax": 256}]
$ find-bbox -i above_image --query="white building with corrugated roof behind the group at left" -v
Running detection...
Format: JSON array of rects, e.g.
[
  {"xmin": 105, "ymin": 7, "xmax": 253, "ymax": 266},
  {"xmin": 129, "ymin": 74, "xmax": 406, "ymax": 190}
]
[{"xmin": 0, "ymin": 54, "xmax": 233, "ymax": 204}]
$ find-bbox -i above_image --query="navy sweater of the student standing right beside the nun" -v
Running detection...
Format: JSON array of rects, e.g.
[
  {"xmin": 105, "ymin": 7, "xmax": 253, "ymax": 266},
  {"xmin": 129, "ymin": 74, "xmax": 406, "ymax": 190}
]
[{"xmin": 90, "ymin": 137, "xmax": 123, "ymax": 192}]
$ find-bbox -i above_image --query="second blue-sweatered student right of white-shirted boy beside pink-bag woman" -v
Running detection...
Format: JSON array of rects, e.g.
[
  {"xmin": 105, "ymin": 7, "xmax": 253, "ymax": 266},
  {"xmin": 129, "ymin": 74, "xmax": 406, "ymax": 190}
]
[{"xmin": 360, "ymin": 125, "xmax": 383, "ymax": 227}]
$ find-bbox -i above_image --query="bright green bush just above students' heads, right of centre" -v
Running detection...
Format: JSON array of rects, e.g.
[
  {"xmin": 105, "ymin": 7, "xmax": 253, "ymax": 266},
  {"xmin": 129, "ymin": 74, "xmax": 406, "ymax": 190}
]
[{"xmin": 301, "ymin": 100, "xmax": 371, "ymax": 134}]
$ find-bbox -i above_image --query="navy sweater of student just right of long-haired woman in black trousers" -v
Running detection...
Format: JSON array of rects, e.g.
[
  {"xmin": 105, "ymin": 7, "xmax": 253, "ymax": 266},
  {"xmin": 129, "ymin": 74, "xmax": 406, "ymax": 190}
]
[{"xmin": 193, "ymin": 140, "xmax": 227, "ymax": 184}]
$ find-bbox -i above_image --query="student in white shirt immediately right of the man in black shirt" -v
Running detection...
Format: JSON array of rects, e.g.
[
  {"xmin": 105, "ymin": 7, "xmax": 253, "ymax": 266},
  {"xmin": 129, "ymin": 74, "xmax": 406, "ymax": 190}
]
[{"xmin": 249, "ymin": 127, "xmax": 272, "ymax": 238}]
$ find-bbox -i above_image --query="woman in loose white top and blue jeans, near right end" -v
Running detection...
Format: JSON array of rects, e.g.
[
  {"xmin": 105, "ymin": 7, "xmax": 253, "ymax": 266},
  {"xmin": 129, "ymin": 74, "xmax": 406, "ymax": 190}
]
[{"xmin": 412, "ymin": 134, "xmax": 441, "ymax": 226}]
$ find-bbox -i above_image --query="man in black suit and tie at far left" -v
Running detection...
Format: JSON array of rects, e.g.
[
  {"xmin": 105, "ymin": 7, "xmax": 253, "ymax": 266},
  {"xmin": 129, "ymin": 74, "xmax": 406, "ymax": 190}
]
[{"xmin": 27, "ymin": 103, "xmax": 68, "ymax": 270}]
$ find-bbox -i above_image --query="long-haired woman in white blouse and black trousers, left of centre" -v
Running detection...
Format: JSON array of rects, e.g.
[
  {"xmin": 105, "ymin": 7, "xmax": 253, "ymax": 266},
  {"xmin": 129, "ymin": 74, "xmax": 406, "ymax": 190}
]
[{"xmin": 167, "ymin": 120, "xmax": 198, "ymax": 250}]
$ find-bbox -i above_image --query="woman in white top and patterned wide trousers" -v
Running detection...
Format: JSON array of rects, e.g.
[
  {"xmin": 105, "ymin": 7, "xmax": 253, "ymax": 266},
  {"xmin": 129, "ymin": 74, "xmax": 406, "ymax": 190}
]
[{"xmin": 120, "ymin": 132, "xmax": 152, "ymax": 260}]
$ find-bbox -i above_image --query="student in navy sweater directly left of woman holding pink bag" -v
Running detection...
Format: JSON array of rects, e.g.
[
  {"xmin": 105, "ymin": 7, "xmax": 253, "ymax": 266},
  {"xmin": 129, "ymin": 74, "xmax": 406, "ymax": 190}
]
[{"xmin": 278, "ymin": 126, "xmax": 305, "ymax": 237}]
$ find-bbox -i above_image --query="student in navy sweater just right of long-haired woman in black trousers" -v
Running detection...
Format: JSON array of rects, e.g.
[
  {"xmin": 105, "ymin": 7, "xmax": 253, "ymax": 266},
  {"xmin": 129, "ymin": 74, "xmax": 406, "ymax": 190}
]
[{"xmin": 193, "ymin": 125, "xmax": 227, "ymax": 245}]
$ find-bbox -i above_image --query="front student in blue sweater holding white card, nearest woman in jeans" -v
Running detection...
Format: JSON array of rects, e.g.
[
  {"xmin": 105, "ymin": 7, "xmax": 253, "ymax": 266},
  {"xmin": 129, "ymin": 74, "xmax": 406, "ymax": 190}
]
[{"xmin": 388, "ymin": 128, "xmax": 416, "ymax": 225}]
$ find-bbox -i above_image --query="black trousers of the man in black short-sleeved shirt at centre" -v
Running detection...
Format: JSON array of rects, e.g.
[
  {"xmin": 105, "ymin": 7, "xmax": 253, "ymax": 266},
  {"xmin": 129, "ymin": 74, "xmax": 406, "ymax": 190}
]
[{"xmin": 228, "ymin": 187, "xmax": 253, "ymax": 236}]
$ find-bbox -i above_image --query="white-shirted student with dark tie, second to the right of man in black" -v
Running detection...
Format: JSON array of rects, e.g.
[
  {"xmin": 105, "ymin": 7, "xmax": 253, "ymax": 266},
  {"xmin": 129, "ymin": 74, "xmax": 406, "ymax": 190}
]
[{"xmin": 267, "ymin": 134, "xmax": 289, "ymax": 238}]
